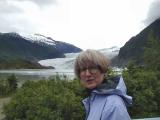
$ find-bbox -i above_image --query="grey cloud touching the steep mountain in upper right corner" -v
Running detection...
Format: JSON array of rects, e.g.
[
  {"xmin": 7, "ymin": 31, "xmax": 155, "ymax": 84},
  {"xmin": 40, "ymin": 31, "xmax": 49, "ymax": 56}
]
[{"xmin": 144, "ymin": 0, "xmax": 160, "ymax": 25}]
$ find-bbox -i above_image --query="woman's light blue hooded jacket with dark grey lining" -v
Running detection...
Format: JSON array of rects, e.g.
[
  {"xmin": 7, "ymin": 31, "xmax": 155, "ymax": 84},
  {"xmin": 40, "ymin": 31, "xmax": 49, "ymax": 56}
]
[{"xmin": 83, "ymin": 77, "xmax": 132, "ymax": 120}]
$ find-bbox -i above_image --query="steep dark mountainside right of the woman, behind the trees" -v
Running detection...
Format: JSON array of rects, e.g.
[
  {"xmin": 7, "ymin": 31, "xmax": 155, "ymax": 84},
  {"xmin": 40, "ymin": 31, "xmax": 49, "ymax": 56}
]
[{"xmin": 112, "ymin": 19, "xmax": 160, "ymax": 67}]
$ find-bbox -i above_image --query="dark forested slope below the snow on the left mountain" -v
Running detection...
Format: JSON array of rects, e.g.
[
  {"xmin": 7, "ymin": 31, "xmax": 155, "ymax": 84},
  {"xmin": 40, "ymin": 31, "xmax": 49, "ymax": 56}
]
[{"xmin": 0, "ymin": 33, "xmax": 63, "ymax": 60}]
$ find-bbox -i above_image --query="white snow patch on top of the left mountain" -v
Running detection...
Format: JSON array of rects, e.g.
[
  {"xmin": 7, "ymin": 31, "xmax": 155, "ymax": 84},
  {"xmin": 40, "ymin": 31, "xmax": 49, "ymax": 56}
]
[{"xmin": 20, "ymin": 33, "xmax": 56, "ymax": 45}]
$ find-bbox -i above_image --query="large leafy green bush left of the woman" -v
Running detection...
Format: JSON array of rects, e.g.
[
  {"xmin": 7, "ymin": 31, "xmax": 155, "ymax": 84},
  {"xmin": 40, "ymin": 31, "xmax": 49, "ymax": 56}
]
[{"xmin": 4, "ymin": 76, "xmax": 84, "ymax": 120}]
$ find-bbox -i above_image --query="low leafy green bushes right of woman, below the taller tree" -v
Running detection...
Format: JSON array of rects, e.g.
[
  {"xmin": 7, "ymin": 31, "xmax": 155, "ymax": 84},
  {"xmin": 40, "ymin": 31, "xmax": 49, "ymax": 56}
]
[{"xmin": 123, "ymin": 65, "xmax": 160, "ymax": 118}]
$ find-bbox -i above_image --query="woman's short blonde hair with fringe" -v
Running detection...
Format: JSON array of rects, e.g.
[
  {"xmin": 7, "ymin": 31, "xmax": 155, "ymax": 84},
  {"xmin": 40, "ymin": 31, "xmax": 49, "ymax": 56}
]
[{"xmin": 74, "ymin": 49, "xmax": 109, "ymax": 78}]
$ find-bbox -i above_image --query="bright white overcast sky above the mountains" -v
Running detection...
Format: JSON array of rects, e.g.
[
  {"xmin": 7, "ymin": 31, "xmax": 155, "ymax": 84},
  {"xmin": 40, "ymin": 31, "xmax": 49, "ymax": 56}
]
[{"xmin": 0, "ymin": 0, "xmax": 160, "ymax": 49}]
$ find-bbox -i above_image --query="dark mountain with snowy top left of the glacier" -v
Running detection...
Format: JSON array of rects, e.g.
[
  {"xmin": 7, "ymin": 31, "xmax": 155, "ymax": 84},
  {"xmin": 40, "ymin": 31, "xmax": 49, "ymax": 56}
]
[{"xmin": 0, "ymin": 33, "xmax": 81, "ymax": 68}]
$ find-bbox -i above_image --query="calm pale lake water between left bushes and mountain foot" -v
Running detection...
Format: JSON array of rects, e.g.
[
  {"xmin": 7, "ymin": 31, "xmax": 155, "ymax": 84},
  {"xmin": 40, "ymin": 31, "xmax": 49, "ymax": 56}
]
[{"xmin": 0, "ymin": 69, "xmax": 74, "ymax": 85}]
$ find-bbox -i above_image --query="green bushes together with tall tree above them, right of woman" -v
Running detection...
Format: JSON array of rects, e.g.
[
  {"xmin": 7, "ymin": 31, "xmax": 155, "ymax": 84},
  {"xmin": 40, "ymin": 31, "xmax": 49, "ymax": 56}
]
[{"xmin": 123, "ymin": 32, "xmax": 160, "ymax": 118}]
